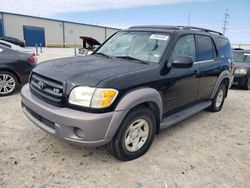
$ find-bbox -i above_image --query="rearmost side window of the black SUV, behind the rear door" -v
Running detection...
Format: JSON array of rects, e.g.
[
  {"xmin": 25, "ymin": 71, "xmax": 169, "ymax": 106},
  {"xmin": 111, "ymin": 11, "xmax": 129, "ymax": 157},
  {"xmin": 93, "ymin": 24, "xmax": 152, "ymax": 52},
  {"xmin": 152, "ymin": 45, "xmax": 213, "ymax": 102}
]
[{"xmin": 216, "ymin": 37, "xmax": 233, "ymax": 58}]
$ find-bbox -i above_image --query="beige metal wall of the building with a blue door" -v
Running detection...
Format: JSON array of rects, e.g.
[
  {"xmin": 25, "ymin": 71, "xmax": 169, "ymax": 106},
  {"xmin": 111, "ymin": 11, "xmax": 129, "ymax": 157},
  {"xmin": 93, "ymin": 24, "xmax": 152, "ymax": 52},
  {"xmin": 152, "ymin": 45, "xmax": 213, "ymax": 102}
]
[{"xmin": 1, "ymin": 12, "xmax": 118, "ymax": 46}]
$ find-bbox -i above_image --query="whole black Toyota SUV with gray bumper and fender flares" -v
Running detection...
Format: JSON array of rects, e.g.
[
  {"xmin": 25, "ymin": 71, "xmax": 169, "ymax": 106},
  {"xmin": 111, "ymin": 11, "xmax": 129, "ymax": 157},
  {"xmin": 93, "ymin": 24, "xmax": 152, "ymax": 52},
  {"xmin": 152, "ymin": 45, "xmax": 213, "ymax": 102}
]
[{"xmin": 21, "ymin": 26, "xmax": 233, "ymax": 160}]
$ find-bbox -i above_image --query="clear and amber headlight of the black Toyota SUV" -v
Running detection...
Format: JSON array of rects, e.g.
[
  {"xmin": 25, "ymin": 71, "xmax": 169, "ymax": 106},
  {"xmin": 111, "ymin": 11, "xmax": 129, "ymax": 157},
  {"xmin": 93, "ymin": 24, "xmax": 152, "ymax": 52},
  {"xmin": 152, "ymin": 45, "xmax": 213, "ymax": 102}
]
[{"xmin": 69, "ymin": 86, "xmax": 118, "ymax": 108}]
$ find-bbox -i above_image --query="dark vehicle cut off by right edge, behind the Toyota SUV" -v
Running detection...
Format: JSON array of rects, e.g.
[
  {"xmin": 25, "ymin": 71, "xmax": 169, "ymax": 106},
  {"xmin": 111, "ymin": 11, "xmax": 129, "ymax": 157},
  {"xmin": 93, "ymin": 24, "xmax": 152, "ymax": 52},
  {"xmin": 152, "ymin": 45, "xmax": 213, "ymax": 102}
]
[{"xmin": 233, "ymin": 49, "xmax": 250, "ymax": 90}]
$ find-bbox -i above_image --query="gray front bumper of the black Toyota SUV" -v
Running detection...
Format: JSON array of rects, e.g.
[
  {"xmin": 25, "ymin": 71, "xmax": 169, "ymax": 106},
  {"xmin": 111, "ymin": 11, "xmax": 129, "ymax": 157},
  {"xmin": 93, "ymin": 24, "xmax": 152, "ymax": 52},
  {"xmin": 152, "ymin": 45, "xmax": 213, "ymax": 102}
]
[{"xmin": 21, "ymin": 84, "xmax": 127, "ymax": 147}]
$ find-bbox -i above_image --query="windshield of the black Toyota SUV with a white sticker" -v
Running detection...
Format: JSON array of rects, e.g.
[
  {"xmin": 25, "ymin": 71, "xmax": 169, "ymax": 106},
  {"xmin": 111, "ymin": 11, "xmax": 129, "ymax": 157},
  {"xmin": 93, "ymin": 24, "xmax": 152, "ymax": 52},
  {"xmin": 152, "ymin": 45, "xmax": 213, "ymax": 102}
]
[{"xmin": 96, "ymin": 31, "xmax": 169, "ymax": 63}]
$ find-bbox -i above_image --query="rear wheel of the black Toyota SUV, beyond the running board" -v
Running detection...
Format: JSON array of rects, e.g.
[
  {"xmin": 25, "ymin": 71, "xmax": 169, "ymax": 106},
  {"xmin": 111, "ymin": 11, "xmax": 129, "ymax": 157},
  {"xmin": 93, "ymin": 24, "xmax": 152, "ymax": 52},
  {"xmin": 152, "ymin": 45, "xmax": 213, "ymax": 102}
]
[{"xmin": 209, "ymin": 83, "xmax": 227, "ymax": 112}]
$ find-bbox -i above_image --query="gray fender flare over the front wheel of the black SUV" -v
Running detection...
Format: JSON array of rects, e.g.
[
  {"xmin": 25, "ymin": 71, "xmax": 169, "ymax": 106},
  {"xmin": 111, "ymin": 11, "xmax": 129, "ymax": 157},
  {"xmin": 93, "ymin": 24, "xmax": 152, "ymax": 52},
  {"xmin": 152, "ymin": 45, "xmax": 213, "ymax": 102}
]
[{"xmin": 105, "ymin": 88, "xmax": 162, "ymax": 140}]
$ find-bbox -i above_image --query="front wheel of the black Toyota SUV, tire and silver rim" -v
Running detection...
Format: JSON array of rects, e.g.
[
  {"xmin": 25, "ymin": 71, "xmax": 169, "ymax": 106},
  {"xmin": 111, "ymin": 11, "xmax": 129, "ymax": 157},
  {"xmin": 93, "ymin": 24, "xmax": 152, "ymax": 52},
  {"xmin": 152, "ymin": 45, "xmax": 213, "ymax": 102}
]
[{"xmin": 109, "ymin": 107, "xmax": 156, "ymax": 161}]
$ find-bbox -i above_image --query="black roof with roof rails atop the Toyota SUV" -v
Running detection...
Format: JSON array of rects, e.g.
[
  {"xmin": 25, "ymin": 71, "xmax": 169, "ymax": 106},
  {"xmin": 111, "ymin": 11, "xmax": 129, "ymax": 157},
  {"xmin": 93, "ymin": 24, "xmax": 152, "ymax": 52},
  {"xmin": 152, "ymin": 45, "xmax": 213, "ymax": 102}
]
[{"xmin": 129, "ymin": 25, "xmax": 223, "ymax": 36}]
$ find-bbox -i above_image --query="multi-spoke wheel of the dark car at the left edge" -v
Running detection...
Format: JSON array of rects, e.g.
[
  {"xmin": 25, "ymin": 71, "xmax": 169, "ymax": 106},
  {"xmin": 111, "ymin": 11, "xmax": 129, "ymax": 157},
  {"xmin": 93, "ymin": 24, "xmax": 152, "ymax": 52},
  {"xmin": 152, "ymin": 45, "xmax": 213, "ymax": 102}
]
[{"xmin": 0, "ymin": 71, "xmax": 18, "ymax": 96}]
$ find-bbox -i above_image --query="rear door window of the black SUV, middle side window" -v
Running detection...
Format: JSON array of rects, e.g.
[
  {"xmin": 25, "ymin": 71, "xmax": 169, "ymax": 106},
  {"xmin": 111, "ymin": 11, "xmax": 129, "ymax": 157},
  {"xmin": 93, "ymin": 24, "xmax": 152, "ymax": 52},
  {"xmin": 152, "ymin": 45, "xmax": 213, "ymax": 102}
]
[{"xmin": 197, "ymin": 35, "xmax": 215, "ymax": 61}]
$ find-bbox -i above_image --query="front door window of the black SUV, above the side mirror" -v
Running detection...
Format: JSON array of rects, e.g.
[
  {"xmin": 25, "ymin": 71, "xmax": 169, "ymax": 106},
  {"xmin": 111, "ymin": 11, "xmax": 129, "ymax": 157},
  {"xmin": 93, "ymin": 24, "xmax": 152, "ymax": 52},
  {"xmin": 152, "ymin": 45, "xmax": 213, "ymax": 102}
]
[{"xmin": 172, "ymin": 35, "xmax": 196, "ymax": 61}]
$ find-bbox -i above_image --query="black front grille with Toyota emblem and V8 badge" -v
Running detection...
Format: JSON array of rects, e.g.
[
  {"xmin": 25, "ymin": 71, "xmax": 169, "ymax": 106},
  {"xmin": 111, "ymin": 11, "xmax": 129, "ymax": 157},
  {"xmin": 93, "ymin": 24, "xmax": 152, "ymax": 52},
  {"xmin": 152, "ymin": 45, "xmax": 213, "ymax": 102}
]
[{"xmin": 30, "ymin": 73, "xmax": 63, "ymax": 106}]
